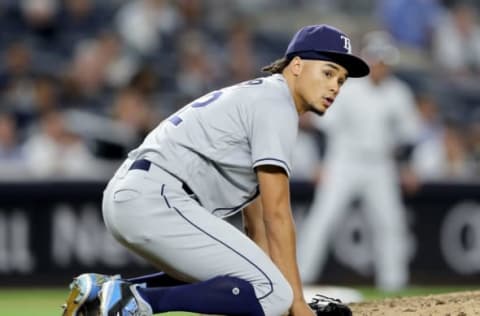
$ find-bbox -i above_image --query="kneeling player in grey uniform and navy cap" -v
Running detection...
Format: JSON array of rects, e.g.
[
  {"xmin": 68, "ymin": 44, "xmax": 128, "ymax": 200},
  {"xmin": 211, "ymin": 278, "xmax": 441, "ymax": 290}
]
[{"xmin": 64, "ymin": 25, "xmax": 369, "ymax": 316}]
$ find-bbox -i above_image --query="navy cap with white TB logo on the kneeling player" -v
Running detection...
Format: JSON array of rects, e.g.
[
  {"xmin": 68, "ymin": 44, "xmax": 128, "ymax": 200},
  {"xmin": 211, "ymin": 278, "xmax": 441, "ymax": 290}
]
[{"xmin": 285, "ymin": 24, "xmax": 370, "ymax": 78}]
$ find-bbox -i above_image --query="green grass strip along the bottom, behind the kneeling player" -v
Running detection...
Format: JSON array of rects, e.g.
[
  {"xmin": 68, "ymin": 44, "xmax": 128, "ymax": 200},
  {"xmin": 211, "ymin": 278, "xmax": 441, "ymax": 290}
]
[{"xmin": 0, "ymin": 286, "xmax": 478, "ymax": 316}]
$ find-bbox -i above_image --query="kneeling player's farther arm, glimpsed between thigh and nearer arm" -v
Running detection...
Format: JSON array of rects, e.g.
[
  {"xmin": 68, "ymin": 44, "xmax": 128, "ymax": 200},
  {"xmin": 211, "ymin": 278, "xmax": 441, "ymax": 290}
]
[{"xmin": 242, "ymin": 197, "xmax": 269, "ymax": 255}]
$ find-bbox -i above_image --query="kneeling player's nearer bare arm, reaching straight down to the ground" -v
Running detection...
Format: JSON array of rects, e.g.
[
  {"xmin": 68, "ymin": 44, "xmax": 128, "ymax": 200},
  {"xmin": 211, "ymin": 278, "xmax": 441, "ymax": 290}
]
[{"xmin": 256, "ymin": 165, "xmax": 313, "ymax": 316}]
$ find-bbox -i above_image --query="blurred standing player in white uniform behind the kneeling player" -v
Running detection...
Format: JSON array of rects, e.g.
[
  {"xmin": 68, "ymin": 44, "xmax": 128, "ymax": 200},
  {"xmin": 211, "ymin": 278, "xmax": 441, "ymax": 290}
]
[{"xmin": 298, "ymin": 31, "xmax": 419, "ymax": 290}]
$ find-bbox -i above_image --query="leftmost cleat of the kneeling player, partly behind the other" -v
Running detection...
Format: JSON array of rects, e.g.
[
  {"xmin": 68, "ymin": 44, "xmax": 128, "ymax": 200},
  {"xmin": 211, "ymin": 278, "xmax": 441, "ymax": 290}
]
[{"xmin": 62, "ymin": 273, "xmax": 120, "ymax": 316}]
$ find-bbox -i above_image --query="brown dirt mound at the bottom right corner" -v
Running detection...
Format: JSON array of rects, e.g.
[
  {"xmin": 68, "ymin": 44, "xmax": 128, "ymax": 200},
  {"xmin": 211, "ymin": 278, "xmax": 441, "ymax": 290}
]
[{"xmin": 349, "ymin": 291, "xmax": 480, "ymax": 316}]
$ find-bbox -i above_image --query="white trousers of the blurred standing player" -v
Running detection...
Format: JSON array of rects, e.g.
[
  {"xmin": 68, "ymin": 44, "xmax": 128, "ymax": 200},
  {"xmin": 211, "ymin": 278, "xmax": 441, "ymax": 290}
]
[{"xmin": 298, "ymin": 157, "xmax": 408, "ymax": 290}]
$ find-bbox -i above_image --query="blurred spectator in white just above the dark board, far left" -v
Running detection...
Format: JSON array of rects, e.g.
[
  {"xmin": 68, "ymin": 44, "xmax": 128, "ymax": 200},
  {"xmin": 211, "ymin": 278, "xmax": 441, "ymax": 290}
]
[{"xmin": 23, "ymin": 111, "xmax": 95, "ymax": 179}]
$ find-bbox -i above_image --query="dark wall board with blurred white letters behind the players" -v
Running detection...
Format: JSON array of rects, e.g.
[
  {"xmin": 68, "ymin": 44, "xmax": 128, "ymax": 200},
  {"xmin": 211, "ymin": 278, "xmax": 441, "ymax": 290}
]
[{"xmin": 0, "ymin": 182, "xmax": 480, "ymax": 285}]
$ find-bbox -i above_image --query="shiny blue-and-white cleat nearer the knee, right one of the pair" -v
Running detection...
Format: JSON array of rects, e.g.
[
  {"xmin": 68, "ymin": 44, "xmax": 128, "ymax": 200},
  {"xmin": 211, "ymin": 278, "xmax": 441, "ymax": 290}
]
[{"xmin": 99, "ymin": 280, "xmax": 153, "ymax": 316}]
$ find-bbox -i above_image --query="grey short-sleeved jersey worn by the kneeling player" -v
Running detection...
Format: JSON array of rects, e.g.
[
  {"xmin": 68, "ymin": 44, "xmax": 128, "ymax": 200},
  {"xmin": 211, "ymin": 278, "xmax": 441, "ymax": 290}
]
[{"xmin": 129, "ymin": 74, "xmax": 298, "ymax": 217}]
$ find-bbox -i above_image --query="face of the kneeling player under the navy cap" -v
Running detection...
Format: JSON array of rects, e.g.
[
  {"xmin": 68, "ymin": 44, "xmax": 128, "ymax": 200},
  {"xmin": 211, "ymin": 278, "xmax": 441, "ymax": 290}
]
[{"xmin": 296, "ymin": 60, "xmax": 348, "ymax": 115}]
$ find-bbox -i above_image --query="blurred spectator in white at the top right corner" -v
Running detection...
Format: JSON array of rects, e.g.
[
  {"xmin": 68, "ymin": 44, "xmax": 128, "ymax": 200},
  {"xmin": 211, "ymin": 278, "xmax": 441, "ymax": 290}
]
[{"xmin": 432, "ymin": 0, "xmax": 480, "ymax": 78}]
